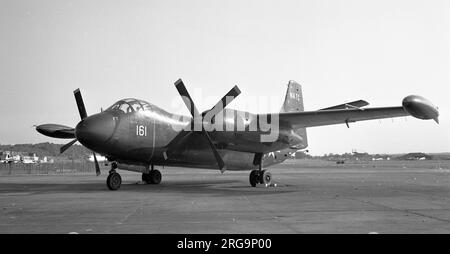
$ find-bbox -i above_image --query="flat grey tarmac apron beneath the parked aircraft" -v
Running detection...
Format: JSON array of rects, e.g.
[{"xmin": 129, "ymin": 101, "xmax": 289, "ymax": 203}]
[{"xmin": 0, "ymin": 162, "xmax": 450, "ymax": 234}]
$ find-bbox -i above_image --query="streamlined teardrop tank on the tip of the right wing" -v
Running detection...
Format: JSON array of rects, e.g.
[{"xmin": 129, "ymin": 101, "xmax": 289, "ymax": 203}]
[{"xmin": 402, "ymin": 95, "xmax": 439, "ymax": 123}]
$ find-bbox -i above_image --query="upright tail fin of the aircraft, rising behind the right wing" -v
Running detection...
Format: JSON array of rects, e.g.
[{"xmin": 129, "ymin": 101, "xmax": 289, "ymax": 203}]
[{"xmin": 281, "ymin": 80, "xmax": 308, "ymax": 149}]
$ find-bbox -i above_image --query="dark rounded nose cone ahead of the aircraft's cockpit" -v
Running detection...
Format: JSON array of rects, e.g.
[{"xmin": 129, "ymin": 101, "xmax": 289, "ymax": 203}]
[{"xmin": 75, "ymin": 112, "xmax": 115, "ymax": 149}]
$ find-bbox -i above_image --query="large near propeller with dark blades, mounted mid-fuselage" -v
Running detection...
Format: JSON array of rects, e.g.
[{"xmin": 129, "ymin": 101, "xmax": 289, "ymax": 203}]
[{"xmin": 175, "ymin": 79, "xmax": 241, "ymax": 173}]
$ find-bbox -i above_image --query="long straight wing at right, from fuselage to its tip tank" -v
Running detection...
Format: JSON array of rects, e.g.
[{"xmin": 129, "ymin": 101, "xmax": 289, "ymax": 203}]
[{"xmin": 279, "ymin": 107, "xmax": 410, "ymax": 129}]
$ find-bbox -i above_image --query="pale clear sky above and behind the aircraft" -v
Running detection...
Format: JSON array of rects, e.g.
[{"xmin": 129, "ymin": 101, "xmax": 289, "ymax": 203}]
[{"xmin": 0, "ymin": 0, "xmax": 450, "ymax": 155}]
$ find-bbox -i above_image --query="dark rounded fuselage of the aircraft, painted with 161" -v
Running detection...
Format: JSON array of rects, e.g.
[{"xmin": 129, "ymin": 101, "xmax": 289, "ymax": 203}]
[{"xmin": 76, "ymin": 102, "xmax": 305, "ymax": 170}]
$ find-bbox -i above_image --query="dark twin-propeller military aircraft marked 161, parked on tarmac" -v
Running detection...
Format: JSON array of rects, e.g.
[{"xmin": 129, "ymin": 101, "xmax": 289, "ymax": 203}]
[{"xmin": 36, "ymin": 79, "xmax": 439, "ymax": 190}]
